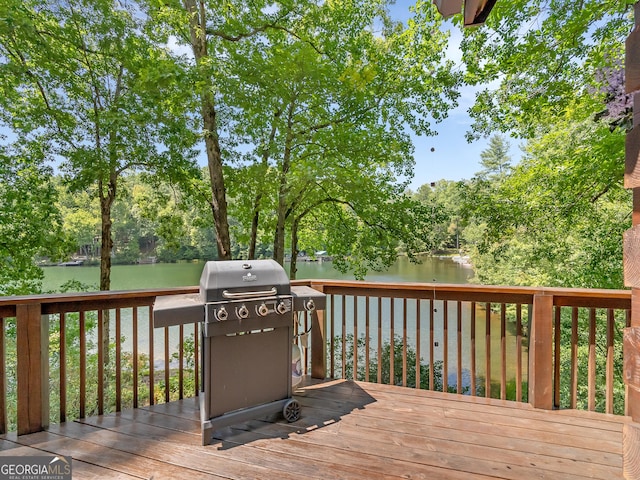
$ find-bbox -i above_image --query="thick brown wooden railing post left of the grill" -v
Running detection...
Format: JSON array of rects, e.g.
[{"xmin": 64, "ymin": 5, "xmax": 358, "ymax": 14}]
[{"xmin": 16, "ymin": 303, "xmax": 49, "ymax": 435}]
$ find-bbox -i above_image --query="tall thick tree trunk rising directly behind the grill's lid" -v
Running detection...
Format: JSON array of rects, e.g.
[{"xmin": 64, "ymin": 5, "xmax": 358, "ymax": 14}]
[{"xmin": 184, "ymin": 0, "xmax": 231, "ymax": 260}]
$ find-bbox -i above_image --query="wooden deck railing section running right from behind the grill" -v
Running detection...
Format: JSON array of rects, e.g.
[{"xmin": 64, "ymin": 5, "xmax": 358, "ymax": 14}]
[{"xmin": 300, "ymin": 281, "xmax": 631, "ymax": 414}]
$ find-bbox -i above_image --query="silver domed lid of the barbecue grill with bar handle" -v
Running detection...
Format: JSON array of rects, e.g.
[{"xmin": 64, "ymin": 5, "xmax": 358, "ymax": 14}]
[{"xmin": 200, "ymin": 260, "xmax": 291, "ymax": 303}]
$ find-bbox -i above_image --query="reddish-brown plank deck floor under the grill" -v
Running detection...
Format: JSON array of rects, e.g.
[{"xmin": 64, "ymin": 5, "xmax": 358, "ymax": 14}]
[{"xmin": 0, "ymin": 380, "xmax": 627, "ymax": 480}]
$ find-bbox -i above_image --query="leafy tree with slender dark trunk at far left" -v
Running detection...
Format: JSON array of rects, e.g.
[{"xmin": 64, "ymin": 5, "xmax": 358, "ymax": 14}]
[{"xmin": 0, "ymin": 0, "xmax": 199, "ymax": 290}]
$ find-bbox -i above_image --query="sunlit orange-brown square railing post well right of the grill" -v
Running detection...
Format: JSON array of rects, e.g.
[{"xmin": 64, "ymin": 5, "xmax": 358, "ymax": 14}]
[{"xmin": 529, "ymin": 294, "xmax": 553, "ymax": 410}]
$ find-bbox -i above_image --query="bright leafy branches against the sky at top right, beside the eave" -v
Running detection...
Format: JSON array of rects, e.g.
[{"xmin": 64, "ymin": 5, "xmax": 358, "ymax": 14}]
[{"xmin": 458, "ymin": 0, "xmax": 635, "ymax": 138}]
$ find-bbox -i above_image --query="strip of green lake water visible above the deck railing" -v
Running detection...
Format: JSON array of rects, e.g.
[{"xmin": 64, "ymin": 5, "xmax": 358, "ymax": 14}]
[{"xmin": 42, "ymin": 257, "xmax": 473, "ymax": 292}]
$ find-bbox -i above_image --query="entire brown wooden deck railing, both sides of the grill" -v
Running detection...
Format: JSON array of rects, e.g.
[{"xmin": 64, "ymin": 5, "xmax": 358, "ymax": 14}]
[{"xmin": 0, "ymin": 280, "xmax": 631, "ymax": 434}]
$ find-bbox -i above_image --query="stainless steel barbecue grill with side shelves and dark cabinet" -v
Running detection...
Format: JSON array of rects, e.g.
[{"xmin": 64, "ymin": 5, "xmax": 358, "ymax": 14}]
[{"xmin": 153, "ymin": 260, "xmax": 325, "ymax": 445}]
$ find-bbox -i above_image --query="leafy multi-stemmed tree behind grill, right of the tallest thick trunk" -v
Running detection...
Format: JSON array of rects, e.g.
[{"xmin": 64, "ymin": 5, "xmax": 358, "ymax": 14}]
[{"xmin": 214, "ymin": 1, "xmax": 457, "ymax": 276}]
